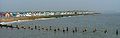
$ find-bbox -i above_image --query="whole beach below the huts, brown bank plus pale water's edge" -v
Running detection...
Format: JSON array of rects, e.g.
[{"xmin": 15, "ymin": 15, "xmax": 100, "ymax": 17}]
[{"xmin": 0, "ymin": 14, "xmax": 99, "ymax": 23}]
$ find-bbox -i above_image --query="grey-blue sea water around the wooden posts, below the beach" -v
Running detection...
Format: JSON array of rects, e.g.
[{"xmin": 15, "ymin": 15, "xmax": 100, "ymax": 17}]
[{"xmin": 0, "ymin": 13, "xmax": 120, "ymax": 38}]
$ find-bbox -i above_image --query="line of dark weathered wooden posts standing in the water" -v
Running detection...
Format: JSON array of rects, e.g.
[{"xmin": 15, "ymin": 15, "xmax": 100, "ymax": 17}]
[{"xmin": 0, "ymin": 24, "xmax": 119, "ymax": 35}]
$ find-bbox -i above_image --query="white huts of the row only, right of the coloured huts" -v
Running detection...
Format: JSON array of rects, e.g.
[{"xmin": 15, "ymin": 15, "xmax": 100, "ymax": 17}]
[{"xmin": 16, "ymin": 11, "xmax": 94, "ymax": 17}]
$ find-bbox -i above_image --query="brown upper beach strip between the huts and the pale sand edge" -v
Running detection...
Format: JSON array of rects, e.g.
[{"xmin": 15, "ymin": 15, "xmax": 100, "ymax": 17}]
[{"xmin": 0, "ymin": 14, "xmax": 79, "ymax": 22}]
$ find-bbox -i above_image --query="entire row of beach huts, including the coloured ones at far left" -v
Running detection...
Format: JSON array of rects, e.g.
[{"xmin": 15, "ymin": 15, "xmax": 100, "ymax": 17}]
[{"xmin": 0, "ymin": 10, "xmax": 95, "ymax": 17}]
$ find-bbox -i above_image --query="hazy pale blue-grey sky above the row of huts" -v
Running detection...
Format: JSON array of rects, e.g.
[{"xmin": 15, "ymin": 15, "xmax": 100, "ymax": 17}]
[{"xmin": 0, "ymin": 0, "xmax": 120, "ymax": 11}]
